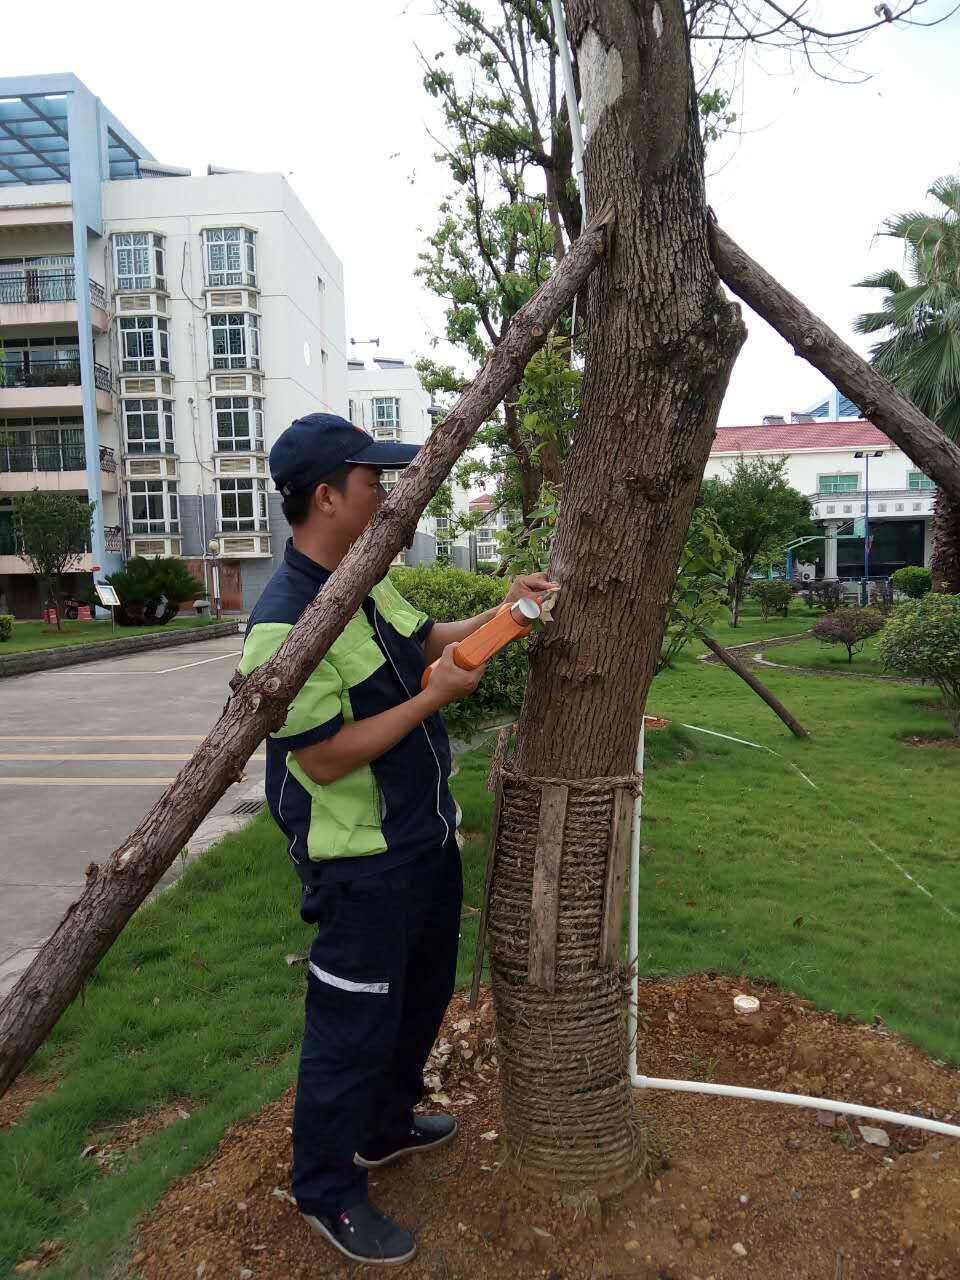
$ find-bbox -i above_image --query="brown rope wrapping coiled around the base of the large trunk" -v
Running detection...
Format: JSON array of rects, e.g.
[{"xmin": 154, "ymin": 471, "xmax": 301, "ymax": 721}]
[{"xmin": 489, "ymin": 765, "xmax": 644, "ymax": 1194}]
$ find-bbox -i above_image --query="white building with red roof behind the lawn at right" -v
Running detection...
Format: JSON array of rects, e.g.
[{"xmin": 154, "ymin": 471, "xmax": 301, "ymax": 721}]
[{"xmin": 705, "ymin": 404, "xmax": 936, "ymax": 579}]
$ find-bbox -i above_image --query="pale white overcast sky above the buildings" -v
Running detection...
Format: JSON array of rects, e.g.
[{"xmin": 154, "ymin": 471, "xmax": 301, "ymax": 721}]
[{"xmin": 0, "ymin": 0, "xmax": 960, "ymax": 425}]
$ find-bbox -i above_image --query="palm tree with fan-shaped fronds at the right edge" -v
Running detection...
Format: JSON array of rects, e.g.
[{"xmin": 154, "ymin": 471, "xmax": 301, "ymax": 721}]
[{"xmin": 854, "ymin": 178, "xmax": 960, "ymax": 593}]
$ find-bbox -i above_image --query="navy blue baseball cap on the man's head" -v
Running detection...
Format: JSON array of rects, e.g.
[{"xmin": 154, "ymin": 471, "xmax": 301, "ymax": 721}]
[{"xmin": 270, "ymin": 413, "xmax": 420, "ymax": 498}]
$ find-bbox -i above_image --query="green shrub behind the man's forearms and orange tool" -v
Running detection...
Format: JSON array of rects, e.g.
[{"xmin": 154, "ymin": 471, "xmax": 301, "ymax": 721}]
[{"xmin": 390, "ymin": 564, "xmax": 527, "ymax": 737}]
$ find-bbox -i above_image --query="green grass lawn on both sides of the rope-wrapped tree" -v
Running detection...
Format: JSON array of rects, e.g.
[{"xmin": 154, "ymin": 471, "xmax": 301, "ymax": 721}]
[{"xmin": 0, "ymin": 634, "xmax": 960, "ymax": 1280}]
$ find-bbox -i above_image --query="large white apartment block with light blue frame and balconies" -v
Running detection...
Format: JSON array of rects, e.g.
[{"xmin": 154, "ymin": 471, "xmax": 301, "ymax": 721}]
[{"xmin": 0, "ymin": 76, "xmax": 347, "ymax": 613}]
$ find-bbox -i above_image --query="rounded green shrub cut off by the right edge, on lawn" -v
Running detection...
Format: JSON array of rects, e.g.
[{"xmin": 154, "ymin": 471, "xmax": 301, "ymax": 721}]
[{"xmin": 879, "ymin": 591, "xmax": 960, "ymax": 737}]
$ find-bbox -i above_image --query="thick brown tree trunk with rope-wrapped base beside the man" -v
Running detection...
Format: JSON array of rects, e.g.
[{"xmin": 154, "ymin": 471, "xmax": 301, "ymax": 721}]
[{"xmin": 490, "ymin": 0, "xmax": 744, "ymax": 1193}]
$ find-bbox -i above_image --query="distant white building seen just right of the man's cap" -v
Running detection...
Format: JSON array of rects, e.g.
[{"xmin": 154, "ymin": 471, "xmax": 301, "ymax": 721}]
[{"xmin": 347, "ymin": 356, "xmax": 470, "ymax": 568}]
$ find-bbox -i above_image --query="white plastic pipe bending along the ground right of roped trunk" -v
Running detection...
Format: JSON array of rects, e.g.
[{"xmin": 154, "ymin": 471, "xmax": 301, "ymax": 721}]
[{"xmin": 627, "ymin": 719, "xmax": 960, "ymax": 1138}]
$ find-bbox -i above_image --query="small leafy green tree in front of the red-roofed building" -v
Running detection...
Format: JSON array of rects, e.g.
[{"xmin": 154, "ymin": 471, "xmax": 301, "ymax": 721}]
[{"xmin": 700, "ymin": 457, "xmax": 817, "ymax": 626}]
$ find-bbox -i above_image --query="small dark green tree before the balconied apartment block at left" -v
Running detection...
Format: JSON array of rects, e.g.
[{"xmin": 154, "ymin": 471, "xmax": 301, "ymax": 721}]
[{"xmin": 13, "ymin": 489, "xmax": 96, "ymax": 631}]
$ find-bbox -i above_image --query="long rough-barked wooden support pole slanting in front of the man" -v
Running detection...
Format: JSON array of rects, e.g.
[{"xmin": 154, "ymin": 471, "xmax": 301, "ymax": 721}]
[{"xmin": 0, "ymin": 211, "xmax": 612, "ymax": 1093}]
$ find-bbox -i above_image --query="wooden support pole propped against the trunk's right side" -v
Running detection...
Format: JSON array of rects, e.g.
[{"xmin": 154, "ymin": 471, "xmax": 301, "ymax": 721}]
[{"xmin": 710, "ymin": 221, "xmax": 960, "ymax": 502}]
